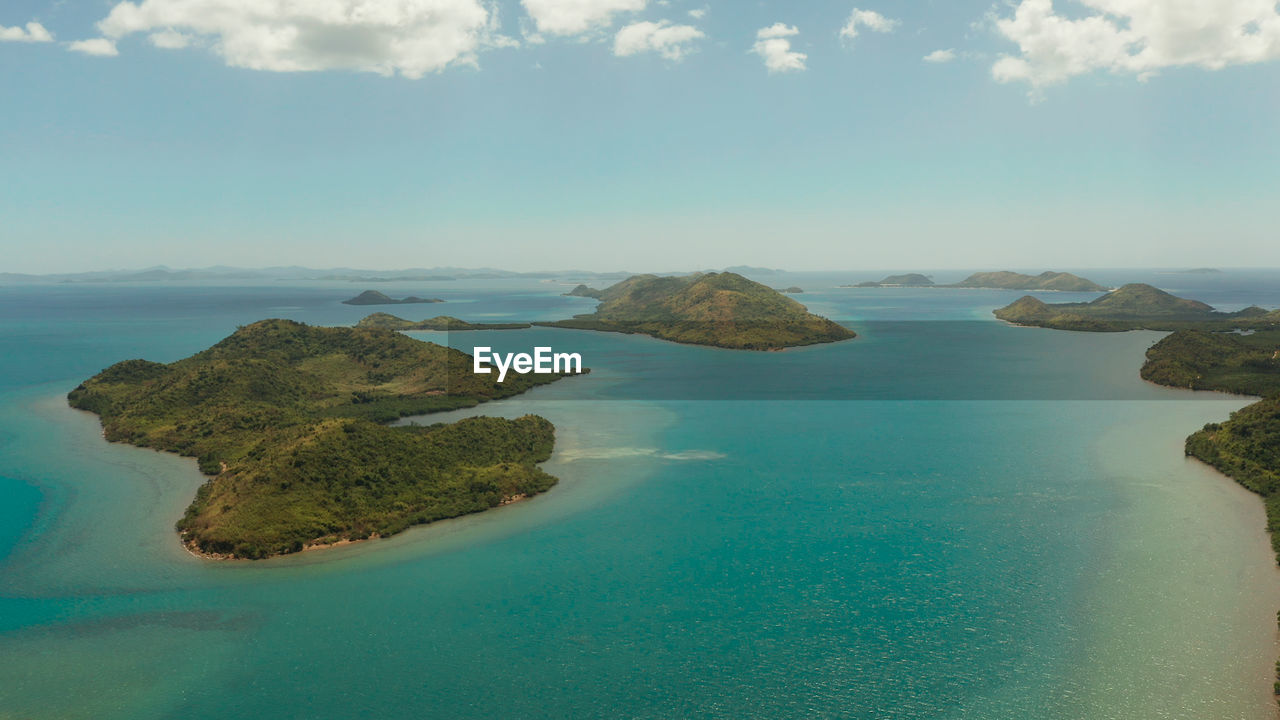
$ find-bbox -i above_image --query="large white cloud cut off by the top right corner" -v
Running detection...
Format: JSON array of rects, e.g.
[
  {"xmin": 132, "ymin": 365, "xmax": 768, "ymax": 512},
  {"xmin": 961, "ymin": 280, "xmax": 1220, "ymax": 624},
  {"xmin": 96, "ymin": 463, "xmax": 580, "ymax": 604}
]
[{"xmin": 991, "ymin": 0, "xmax": 1280, "ymax": 87}]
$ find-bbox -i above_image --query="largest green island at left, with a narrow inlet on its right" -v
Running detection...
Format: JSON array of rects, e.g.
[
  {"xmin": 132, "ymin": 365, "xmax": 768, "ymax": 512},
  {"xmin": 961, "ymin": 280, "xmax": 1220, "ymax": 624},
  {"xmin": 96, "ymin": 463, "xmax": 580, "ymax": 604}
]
[{"xmin": 68, "ymin": 319, "xmax": 583, "ymax": 559}]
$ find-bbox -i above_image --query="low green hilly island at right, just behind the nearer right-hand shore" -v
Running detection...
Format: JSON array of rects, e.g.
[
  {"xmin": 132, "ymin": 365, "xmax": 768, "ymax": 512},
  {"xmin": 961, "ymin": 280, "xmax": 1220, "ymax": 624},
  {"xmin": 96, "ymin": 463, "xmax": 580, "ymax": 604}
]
[{"xmin": 995, "ymin": 283, "xmax": 1280, "ymax": 332}]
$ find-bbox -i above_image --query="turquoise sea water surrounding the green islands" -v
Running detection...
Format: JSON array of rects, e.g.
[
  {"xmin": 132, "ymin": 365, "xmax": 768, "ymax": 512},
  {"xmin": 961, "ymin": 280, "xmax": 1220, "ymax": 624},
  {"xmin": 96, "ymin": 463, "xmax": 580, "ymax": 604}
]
[{"xmin": 0, "ymin": 275, "xmax": 1280, "ymax": 719}]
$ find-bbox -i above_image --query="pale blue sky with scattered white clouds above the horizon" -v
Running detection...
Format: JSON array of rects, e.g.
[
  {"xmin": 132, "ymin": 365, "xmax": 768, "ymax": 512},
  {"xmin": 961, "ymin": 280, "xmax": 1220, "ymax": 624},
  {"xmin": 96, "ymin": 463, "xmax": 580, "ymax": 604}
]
[{"xmin": 0, "ymin": 0, "xmax": 1280, "ymax": 273}]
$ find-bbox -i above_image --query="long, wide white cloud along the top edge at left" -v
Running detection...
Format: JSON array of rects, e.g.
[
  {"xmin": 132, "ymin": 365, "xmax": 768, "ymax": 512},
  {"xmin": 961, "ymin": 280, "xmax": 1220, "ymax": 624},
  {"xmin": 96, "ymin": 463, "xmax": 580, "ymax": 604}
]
[{"xmin": 79, "ymin": 0, "xmax": 511, "ymax": 78}]
